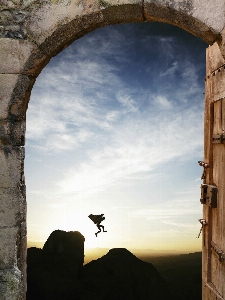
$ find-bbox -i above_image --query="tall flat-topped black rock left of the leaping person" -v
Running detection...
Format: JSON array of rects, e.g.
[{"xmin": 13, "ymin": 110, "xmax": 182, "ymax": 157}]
[{"xmin": 27, "ymin": 230, "xmax": 85, "ymax": 300}]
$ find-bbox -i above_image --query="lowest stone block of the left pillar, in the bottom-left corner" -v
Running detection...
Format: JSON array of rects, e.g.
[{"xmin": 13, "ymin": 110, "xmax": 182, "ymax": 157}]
[{"xmin": 0, "ymin": 268, "xmax": 22, "ymax": 300}]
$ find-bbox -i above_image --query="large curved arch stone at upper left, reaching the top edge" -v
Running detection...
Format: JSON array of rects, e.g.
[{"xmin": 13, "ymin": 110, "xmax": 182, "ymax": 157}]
[{"xmin": 24, "ymin": 0, "xmax": 107, "ymax": 56}]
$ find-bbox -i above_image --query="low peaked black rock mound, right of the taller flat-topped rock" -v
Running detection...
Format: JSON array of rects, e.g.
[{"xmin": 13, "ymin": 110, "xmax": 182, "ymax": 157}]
[{"xmin": 80, "ymin": 248, "xmax": 172, "ymax": 300}]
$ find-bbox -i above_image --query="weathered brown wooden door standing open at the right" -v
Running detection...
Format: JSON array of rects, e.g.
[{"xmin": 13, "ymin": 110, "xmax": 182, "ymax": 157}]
[{"xmin": 202, "ymin": 43, "xmax": 225, "ymax": 300}]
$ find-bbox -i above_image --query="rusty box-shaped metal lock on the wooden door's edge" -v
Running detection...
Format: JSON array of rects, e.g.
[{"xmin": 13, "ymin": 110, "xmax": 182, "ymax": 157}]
[{"xmin": 200, "ymin": 184, "xmax": 218, "ymax": 208}]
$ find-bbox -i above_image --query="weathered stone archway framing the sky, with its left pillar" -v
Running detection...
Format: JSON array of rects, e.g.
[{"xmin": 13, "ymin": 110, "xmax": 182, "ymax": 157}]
[{"xmin": 0, "ymin": 0, "xmax": 225, "ymax": 300}]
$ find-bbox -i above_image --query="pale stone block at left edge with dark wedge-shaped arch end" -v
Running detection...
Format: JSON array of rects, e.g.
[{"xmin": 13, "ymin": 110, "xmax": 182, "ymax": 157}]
[{"xmin": 0, "ymin": 38, "xmax": 49, "ymax": 75}]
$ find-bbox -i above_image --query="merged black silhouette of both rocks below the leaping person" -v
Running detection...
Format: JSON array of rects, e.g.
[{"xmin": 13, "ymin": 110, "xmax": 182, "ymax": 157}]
[{"xmin": 27, "ymin": 230, "xmax": 172, "ymax": 300}]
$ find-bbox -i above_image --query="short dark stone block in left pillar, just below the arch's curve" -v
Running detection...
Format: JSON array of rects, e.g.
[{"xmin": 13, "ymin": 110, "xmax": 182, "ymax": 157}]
[{"xmin": 0, "ymin": 120, "xmax": 26, "ymax": 146}]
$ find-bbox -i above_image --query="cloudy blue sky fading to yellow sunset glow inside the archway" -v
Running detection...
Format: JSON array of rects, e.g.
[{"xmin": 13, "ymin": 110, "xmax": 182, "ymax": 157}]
[{"xmin": 25, "ymin": 22, "xmax": 208, "ymax": 252}]
